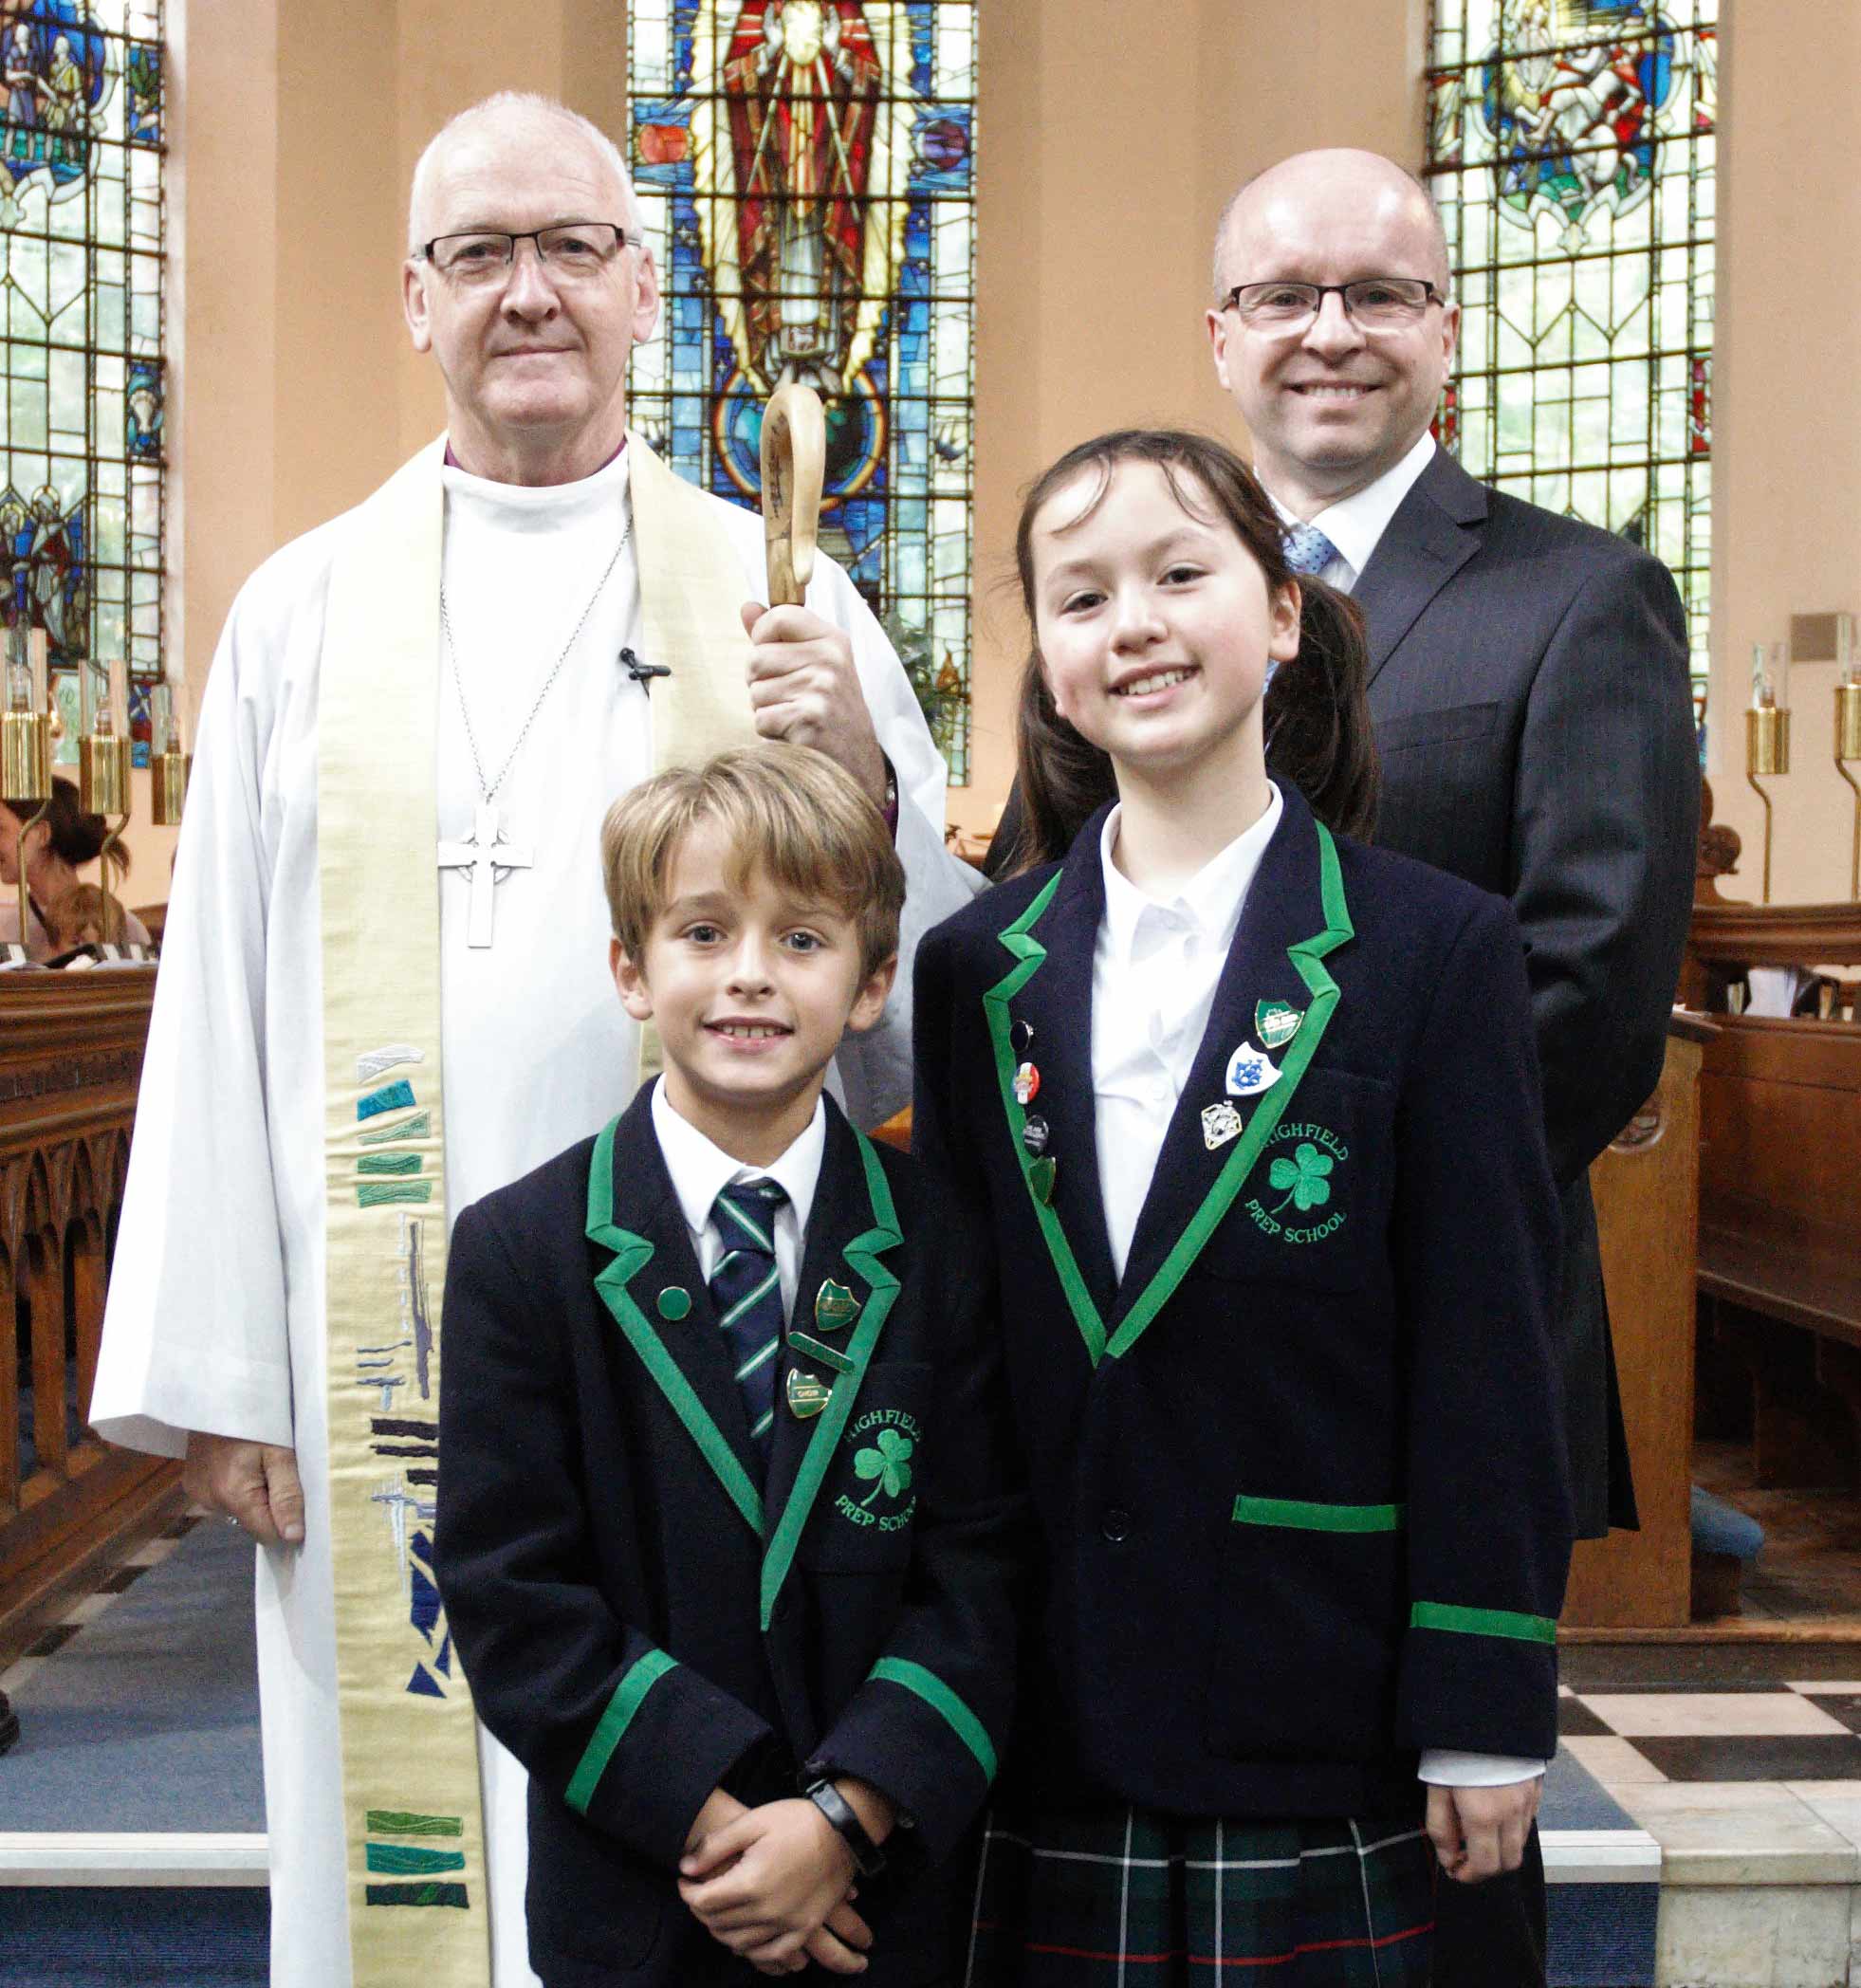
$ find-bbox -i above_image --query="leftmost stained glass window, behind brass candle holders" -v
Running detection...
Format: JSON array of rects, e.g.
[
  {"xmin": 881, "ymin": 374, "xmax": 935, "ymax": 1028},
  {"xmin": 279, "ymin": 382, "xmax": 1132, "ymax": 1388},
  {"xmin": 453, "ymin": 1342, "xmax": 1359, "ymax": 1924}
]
[{"xmin": 0, "ymin": 0, "xmax": 165, "ymax": 765}]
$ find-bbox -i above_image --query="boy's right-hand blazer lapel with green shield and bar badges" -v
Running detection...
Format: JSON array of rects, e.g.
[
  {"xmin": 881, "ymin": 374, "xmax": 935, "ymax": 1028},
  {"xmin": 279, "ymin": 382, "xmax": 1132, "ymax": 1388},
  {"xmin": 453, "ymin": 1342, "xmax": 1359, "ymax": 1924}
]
[{"xmin": 762, "ymin": 1099, "xmax": 903, "ymax": 1630}]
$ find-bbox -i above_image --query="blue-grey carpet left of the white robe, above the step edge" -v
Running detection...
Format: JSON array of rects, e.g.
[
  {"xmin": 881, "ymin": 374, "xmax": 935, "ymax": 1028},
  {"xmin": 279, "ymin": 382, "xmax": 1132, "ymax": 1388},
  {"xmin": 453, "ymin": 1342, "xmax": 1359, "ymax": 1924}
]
[{"xmin": 0, "ymin": 1519, "xmax": 265, "ymax": 1831}]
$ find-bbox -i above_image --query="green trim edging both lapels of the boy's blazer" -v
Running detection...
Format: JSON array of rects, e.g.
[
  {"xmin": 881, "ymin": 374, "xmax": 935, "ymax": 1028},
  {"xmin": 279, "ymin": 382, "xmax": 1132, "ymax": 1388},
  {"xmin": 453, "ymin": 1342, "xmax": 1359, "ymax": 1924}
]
[{"xmin": 586, "ymin": 1119, "xmax": 905, "ymax": 1630}]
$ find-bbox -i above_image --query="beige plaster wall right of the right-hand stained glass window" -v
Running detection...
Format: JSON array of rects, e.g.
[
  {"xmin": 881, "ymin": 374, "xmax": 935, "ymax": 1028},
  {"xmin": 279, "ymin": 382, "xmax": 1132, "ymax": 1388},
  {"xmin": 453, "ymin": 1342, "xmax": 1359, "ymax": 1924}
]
[{"xmin": 1708, "ymin": 0, "xmax": 1861, "ymax": 905}]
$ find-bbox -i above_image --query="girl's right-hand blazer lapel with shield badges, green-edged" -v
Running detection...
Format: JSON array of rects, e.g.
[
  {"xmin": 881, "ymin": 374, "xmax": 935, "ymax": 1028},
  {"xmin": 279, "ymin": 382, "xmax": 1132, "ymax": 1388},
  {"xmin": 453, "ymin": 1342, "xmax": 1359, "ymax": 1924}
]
[{"xmin": 1105, "ymin": 787, "xmax": 1352, "ymax": 1360}]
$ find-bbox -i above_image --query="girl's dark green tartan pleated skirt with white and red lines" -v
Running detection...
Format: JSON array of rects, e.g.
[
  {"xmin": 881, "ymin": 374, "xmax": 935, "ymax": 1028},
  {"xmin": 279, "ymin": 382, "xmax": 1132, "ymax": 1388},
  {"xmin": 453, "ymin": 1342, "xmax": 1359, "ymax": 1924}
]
[{"xmin": 965, "ymin": 1803, "xmax": 1435, "ymax": 1988}]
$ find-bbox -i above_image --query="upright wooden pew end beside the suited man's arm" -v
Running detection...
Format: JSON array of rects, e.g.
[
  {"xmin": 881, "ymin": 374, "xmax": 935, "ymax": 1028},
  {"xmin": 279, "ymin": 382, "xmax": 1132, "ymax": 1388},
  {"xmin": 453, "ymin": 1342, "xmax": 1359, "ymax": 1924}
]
[{"xmin": 1563, "ymin": 1014, "xmax": 1718, "ymax": 1632}]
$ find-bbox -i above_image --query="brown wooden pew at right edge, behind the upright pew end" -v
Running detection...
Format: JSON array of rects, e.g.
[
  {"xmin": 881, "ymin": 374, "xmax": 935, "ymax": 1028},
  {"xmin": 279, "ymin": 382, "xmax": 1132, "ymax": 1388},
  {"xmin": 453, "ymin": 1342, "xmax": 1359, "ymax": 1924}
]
[{"xmin": 1700, "ymin": 1016, "xmax": 1861, "ymax": 1485}]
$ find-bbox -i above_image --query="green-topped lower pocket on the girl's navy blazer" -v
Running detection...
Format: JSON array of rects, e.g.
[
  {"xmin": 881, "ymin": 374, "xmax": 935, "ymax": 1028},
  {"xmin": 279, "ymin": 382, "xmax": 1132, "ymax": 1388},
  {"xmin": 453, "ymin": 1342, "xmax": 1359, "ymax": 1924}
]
[{"xmin": 1207, "ymin": 1493, "xmax": 1406, "ymax": 1761}]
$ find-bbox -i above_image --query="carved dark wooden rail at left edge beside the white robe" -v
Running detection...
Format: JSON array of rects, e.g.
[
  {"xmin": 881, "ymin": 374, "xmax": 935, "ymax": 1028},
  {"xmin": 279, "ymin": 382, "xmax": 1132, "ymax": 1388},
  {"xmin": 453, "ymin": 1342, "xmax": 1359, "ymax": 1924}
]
[{"xmin": 0, "ymin": 966, "xmax": 179, "ymax": 1642}]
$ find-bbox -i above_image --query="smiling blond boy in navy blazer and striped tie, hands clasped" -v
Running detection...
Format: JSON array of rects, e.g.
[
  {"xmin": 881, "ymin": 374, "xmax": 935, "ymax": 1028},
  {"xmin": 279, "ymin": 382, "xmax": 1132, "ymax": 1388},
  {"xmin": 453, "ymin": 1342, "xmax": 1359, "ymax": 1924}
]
[{"xmin": 437, "ymin": 746, "xmax": 1018, "ymax": 1988}]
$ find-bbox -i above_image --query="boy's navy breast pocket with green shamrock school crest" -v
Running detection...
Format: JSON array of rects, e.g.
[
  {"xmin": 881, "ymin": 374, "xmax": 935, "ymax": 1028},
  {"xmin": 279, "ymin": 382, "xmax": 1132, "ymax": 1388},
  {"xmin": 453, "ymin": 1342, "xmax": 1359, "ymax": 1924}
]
[{"xmin": 795, "ymin": 1360, "xmax": 936, "ymax": 1574}]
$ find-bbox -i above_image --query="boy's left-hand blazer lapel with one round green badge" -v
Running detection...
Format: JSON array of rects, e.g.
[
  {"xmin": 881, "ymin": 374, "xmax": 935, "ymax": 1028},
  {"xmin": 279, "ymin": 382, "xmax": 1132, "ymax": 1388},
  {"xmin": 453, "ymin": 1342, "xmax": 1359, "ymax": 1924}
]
[{"xmin": 586, "ymin": 1085, "xmax": 764, "ymax": 1538}]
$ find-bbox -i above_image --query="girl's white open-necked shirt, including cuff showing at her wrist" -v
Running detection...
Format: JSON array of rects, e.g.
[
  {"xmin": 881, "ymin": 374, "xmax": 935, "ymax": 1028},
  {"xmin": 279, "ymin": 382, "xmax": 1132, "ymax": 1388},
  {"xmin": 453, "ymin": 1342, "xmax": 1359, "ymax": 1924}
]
[{"xmin": 1081, "ymin": 791, "xmax": 1545, "ymax": 1787}]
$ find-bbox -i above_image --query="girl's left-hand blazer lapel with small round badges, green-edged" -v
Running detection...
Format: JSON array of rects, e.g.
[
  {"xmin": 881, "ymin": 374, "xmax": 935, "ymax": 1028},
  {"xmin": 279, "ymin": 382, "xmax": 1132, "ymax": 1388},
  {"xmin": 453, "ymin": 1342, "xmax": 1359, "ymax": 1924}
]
[{"xmin": 983, "ymin": 809, "xmax": 1117, "ymax": 1364}]
